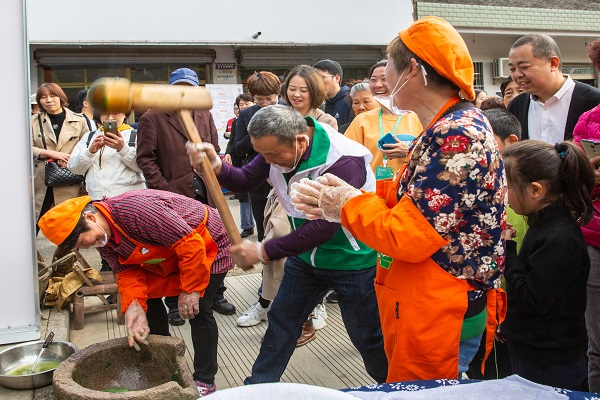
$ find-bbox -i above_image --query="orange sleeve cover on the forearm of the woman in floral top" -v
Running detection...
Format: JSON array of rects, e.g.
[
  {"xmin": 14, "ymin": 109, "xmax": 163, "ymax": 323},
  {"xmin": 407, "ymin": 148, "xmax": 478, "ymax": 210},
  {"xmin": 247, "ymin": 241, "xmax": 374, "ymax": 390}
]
[{"xmin": 341, "ymin": 193, "xmax": 449, "ymax": 263}]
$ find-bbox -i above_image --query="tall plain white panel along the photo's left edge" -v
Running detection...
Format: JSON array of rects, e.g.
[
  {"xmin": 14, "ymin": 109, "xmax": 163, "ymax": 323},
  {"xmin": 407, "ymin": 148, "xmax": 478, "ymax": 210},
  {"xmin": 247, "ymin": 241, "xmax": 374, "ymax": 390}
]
[{"xmin": 0, "ymin": 0, "xmax": 40, "ymax": 343}]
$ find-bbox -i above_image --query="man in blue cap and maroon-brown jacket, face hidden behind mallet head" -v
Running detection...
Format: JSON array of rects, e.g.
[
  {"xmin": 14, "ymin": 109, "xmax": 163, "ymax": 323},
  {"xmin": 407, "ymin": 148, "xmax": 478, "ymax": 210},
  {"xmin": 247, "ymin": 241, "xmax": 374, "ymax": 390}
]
[{"xmin": 137, "ymin": 68, "xmax": 235, "ymax": 325}]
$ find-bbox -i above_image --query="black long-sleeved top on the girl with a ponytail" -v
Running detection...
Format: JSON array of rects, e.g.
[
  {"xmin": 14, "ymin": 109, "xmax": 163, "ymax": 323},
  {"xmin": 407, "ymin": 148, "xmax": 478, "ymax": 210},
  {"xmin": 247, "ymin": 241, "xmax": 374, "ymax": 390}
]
[{"xmin": 501, "ymin": 201, "xmax": 590, "ymax": 365}]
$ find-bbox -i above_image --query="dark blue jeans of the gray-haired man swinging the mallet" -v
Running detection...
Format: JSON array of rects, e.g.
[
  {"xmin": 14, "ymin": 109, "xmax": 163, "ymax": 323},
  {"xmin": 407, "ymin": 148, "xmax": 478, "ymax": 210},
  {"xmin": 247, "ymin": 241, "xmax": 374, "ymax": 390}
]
[{"xmin": 244, "ymin": 257, "xmax": 388, "ymax": 384}]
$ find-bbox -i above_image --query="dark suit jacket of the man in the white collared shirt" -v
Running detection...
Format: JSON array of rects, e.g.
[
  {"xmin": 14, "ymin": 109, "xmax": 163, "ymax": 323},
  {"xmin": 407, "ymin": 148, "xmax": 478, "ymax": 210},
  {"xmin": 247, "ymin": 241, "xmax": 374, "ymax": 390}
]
[{"xmin": 508, "ymin": 81, "xmax": 600, "ymax": 140}]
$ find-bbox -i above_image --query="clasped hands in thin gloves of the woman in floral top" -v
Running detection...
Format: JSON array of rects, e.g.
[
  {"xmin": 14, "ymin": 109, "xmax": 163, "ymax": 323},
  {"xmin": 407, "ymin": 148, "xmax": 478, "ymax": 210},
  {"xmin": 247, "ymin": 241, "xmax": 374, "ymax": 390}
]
[{"xmin": 290, "ymin": 174, "xmax": 362, "ymax": 223}]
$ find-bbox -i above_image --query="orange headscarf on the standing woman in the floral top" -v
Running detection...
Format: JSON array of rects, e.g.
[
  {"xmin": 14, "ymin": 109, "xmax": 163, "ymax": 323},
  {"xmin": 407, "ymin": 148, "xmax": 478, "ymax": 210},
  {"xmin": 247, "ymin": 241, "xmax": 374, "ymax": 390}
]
[{"xmin": 398, "ymin": 16, "xmax": 475, "ymax": 100}]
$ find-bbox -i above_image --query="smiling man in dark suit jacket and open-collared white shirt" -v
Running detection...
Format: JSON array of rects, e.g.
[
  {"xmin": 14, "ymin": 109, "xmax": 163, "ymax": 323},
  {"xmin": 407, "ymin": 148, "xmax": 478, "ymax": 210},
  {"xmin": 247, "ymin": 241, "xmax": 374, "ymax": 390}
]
[{"xmin": 508, "ymin": 33, "xmax": 600, "ymax": 144}]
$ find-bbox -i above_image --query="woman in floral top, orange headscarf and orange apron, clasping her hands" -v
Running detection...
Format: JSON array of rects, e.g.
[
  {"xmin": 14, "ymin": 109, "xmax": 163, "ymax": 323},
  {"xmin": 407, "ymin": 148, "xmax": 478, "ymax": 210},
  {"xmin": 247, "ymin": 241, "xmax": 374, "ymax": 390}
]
[{"xmin": 295, "ymin": 17, "xmax": 506, "ymax": 382}]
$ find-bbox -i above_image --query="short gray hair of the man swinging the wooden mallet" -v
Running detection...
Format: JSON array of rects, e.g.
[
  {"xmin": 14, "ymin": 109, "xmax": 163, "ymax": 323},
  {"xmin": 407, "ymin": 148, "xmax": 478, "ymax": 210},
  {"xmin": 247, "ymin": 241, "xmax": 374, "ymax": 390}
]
[{"xmin": 248, "ymin": 104, "xmax": 308, "ymax": 143}]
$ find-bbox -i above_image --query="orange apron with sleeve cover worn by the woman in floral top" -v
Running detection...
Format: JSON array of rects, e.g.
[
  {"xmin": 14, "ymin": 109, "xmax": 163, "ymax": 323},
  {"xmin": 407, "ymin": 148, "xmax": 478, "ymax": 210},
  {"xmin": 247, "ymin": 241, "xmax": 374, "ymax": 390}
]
[{"xmin": 342, "ymin": 163, "xmax": 506, "ymax": 382}]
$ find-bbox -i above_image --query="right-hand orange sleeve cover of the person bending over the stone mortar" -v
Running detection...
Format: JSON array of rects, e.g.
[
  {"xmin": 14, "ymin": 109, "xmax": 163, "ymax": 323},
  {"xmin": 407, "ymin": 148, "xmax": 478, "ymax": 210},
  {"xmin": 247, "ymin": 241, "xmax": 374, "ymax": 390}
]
[{"xmin": 172, "ymin": 230, "xmax": 213, "ymax": 297}]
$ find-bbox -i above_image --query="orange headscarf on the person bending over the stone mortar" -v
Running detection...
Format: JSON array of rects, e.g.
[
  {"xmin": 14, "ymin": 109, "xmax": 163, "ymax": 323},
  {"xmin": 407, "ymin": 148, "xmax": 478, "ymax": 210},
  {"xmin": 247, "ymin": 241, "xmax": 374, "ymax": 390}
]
[{"xmin": 38, "ymin": 196, "xmax": 92, "ymax": 246}]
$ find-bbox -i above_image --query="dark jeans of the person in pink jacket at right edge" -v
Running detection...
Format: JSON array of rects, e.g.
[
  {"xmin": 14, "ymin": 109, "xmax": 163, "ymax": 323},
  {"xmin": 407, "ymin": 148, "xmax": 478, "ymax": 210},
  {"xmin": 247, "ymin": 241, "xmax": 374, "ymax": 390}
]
[{"xmin": 585, "ymin": 246, "xmax": 600, "ymax": 393}]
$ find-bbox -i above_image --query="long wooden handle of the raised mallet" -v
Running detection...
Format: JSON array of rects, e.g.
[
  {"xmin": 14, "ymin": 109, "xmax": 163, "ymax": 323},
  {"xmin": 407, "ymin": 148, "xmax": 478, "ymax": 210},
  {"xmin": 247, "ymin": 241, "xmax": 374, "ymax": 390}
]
[{"xmin": 177, "ymin": 110, "xmax": 252, "ymax": 260}]
